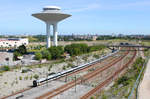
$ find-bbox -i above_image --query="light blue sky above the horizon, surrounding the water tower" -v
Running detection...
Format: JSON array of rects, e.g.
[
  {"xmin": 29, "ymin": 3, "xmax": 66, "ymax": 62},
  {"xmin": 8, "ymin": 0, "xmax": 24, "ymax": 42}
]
[{"xmin": 0, "ymin": 0, "xmax": 150, "ymax": 35}]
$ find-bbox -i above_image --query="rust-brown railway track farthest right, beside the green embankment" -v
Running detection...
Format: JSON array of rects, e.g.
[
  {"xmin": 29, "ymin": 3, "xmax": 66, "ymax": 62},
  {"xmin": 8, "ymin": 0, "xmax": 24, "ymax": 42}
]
[{"xmin": 80, "ymin": 51, "xmax": 136, "ymax": 99}]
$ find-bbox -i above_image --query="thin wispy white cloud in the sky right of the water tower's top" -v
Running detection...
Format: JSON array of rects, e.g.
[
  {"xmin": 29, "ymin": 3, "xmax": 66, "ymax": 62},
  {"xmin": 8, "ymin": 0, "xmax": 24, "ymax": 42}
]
[{"xmin": 64, "ymin": 4, "xmax": 100, "ymax": 12}]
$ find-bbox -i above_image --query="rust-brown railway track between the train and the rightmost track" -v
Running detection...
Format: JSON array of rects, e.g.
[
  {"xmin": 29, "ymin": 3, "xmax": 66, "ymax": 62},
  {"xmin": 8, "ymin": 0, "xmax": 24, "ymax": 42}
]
[{"xmin": 37, "ymin": 49, "xmax": 129, "ymax": 99}]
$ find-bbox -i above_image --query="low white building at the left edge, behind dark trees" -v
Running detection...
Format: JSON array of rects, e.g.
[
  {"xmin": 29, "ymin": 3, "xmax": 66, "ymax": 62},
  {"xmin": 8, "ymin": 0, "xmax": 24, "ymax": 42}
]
[{"xmin": 0, "ymin": 38, "xmax": 29, "ymax": 48}]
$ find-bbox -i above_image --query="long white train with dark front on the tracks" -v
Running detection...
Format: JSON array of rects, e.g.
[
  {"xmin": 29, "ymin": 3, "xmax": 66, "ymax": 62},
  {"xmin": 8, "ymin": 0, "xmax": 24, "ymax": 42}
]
[{"xmin": 33, "ymin": 50, "xmax": 118, "ymax": 87}]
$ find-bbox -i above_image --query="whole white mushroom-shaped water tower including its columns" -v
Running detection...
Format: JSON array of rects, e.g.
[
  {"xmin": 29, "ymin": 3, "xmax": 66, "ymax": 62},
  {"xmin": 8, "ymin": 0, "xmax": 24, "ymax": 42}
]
[{"xmin": 32, "ymin": 6, "xmax": 71, "ymax": 48}]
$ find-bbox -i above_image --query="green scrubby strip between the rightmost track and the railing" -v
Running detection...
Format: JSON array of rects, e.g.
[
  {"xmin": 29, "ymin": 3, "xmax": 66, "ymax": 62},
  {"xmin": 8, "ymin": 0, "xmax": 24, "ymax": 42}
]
[{"xmin": 98, "ymin": 57, "xmax": 145, "ymax": 99}]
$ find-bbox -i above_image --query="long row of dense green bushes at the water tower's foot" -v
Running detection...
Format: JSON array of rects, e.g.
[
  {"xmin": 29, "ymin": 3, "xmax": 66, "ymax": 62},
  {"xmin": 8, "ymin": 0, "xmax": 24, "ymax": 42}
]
[{"xmin": 35, "ymin": 43, "xmax": 105, "ymax": 60}]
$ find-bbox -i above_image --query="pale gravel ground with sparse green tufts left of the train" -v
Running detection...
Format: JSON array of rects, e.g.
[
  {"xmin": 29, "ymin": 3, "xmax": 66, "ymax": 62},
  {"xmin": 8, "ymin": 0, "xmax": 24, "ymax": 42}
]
[{"xmin": 0, "ymin": 50, "xmax": 109, "ymax": 97}]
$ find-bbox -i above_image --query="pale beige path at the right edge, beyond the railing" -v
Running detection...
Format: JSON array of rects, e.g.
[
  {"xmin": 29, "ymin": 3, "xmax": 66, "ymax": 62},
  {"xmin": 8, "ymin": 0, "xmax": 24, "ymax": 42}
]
[{"xmin": 139, "ymin": 59, "xmax": 150, "ymax": 99}]
